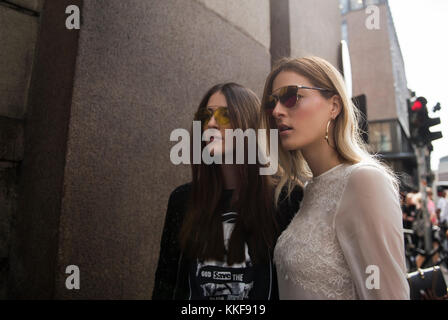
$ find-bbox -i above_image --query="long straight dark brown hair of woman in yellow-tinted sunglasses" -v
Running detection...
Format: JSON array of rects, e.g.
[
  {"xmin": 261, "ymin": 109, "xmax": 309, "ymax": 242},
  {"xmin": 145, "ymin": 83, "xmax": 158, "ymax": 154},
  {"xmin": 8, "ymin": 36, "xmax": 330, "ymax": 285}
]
[{"xmin": 179, "ymin": 83, "xmax": 278, "ymax": 265}]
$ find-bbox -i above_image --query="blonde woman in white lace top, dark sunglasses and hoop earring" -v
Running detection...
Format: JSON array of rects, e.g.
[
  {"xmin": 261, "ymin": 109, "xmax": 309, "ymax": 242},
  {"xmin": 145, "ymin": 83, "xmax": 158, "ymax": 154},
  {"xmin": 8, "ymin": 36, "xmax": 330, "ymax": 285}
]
[{"xmin": 262, "ymin": 57, "xmax": 409, "ymax": 299}]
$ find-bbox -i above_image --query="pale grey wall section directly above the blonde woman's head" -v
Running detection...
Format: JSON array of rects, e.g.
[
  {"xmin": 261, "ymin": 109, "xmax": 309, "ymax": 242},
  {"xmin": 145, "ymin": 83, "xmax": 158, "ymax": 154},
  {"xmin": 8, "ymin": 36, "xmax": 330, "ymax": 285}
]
[{"xmin": 289, "ymin": 0, "xmax": 342, "ymax": 68}]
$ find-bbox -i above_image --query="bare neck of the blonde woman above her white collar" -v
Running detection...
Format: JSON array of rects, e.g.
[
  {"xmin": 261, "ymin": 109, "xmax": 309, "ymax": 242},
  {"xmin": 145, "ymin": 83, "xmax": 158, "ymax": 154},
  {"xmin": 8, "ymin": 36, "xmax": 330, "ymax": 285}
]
[{"xmin": 301, "ymin": 142, "xmax": 343, "ymax": 177}]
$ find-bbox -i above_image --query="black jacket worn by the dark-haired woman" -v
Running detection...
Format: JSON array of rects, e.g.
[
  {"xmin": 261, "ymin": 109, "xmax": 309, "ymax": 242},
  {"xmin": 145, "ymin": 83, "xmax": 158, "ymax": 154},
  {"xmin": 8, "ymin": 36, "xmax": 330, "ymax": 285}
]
[{"xmin": 152, "ymin": 183, "xmax": 303, "ymax": 300}]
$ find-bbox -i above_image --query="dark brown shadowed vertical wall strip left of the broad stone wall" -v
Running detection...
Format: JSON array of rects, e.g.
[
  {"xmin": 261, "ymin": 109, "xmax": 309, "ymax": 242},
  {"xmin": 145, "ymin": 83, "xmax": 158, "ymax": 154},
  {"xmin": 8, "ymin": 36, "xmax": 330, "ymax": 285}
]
[{"xmin": 8, "ymin": 0, "xmax": 82, "ymax": 299}]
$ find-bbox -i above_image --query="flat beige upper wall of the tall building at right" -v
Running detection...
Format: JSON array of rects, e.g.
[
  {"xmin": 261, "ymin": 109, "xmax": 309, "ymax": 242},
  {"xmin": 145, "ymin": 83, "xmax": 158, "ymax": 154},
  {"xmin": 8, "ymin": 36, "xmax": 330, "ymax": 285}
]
[{"xmin": 345, "ymin": 5, "xmax": 397, "ymax": 121}]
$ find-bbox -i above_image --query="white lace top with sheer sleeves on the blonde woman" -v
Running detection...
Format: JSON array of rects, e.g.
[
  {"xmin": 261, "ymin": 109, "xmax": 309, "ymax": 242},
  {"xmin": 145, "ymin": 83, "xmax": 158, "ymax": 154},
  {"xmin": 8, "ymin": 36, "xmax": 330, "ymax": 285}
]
[{"xmin": 274, "ymin": 163, "xmax": 409, "ymax": 299}]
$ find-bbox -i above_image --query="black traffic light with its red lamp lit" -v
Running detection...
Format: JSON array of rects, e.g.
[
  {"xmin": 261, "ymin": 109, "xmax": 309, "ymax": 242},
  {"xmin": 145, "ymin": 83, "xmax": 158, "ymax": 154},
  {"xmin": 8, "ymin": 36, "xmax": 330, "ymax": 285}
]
[{"xmin": 408, "ymin": 97, "xmax": 442, "ymax": 145}]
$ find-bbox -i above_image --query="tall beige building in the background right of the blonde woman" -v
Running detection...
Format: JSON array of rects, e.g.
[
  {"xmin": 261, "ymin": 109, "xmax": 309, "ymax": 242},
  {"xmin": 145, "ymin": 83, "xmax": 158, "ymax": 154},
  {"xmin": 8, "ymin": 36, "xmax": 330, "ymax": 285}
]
[{"xmin": 340, "ymin": 0, "xmax": 418, "ymax": 189}]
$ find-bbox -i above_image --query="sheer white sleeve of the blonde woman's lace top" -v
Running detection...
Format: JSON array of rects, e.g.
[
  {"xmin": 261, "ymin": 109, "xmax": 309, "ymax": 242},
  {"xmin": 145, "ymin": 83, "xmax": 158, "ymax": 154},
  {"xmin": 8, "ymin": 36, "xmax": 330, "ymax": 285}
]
[{"xmin": 334, "ymin": 165, "xmax": 409, "ymax": 300}]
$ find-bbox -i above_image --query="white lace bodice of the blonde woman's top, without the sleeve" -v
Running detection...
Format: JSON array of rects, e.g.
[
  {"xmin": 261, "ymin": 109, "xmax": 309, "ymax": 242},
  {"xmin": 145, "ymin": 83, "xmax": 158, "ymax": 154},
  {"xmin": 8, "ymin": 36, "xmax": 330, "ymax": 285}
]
[{"xmin": 274, "ymin": 164, "xmax": 357, "ymax": 299}]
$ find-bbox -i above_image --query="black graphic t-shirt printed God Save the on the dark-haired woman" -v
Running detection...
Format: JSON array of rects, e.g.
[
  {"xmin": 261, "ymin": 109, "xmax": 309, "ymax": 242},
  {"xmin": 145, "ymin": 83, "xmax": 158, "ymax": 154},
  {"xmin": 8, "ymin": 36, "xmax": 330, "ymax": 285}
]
[{"xmin": 189, "ymin": 190, "xmax": 254, "ymax": 300}]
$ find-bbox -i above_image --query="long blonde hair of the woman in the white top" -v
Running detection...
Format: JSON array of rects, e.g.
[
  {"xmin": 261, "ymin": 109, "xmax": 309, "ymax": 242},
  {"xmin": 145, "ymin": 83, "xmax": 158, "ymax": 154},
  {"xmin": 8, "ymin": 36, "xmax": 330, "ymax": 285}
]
[{"xmin": 261, "ymin": 56, "xmax": 398, "ymax": 203}]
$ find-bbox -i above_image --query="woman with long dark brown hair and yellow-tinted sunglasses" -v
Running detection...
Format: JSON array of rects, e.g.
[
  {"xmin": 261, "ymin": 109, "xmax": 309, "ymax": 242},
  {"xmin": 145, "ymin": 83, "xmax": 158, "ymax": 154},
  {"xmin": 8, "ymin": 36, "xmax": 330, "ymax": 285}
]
[{"xmin": 153, "ymin": 83, "xmax": 302, "ymax": 300}]
